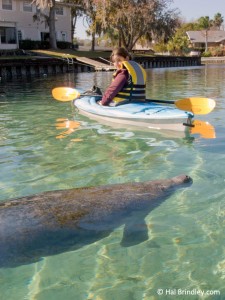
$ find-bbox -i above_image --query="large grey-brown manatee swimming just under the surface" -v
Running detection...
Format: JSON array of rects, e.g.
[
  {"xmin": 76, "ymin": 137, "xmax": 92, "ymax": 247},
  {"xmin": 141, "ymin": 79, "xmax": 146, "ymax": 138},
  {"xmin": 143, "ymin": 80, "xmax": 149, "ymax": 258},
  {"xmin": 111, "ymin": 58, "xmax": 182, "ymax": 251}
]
[{"xmin": 0, "ymin": 175, "xmax": 192, "ymax": 268}]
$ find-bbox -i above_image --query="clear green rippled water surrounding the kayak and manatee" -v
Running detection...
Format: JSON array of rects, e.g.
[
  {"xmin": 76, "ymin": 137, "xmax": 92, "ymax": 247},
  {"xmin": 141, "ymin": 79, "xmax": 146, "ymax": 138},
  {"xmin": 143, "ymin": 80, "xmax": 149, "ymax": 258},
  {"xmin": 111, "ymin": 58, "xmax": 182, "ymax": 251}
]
[{"xmin": 0, "ymin": 65, "xmax": 225, "ymax": 300}]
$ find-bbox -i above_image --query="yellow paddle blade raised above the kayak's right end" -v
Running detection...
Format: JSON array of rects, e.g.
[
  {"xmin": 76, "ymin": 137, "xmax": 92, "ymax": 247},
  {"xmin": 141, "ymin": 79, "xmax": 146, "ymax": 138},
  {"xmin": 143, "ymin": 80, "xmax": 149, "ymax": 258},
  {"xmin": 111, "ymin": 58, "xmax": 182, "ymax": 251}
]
[{"xmin": 175, "ymin": 97, "xmax": 216, "ymax": 115}]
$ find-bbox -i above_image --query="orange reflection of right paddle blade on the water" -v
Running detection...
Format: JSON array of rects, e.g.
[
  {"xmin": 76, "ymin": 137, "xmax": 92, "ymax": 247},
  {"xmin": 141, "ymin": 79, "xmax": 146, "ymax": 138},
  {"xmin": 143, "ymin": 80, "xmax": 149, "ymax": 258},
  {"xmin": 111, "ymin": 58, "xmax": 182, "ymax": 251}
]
[{"xmin": 191, "ymin": 120, "xmax": 216, "ymax": 139}]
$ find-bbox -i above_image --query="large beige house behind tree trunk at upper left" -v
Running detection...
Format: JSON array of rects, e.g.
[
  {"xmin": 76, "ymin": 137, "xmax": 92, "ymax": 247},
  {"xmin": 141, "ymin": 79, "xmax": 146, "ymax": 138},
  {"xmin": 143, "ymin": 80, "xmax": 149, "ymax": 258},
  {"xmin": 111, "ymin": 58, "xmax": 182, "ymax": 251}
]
[{"xmin": 0, "ymin": 0, "xmax": 71, "ymax": 49}]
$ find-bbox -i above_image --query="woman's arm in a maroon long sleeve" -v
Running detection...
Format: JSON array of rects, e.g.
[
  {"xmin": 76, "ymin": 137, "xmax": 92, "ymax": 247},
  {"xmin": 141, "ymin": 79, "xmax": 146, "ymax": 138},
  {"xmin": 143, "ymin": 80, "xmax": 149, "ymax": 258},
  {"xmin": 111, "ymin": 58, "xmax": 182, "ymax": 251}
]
[{"xmin": 100, "ymin": 69, "xmax": 129, "ymax": 105}]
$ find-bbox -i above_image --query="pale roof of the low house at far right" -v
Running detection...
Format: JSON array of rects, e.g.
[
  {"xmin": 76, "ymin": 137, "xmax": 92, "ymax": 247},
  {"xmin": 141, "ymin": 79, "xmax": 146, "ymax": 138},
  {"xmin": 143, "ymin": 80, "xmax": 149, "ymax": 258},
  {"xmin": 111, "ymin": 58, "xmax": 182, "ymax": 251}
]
[{"xmin": 186, "ymin": 30, "xmax": 225, "ymax": 43}]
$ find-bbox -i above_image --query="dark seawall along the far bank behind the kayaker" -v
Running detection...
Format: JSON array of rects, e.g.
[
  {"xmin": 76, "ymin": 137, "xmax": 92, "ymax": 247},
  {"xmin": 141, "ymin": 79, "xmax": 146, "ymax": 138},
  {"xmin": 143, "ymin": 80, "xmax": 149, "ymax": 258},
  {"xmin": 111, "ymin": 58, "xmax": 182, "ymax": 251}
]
[{"xmin": 0, "ymin": 55, "xmax": 202, "ymax": 80}]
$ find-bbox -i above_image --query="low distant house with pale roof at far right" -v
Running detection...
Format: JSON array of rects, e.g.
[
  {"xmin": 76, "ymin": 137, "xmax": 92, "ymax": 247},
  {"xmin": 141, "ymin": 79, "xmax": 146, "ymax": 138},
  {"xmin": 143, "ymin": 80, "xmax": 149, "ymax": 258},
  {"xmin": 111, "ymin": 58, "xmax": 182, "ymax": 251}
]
[{"xmin": 186, "ymin": 30, "xmax": 225, "ymax": 48}]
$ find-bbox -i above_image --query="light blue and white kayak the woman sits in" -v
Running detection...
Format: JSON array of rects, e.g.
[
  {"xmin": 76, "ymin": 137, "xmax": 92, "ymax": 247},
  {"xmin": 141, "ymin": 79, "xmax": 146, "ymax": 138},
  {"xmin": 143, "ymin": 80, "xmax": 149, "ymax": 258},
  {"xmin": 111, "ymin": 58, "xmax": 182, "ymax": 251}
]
[{"xmin": 73, "ymin": 96, "xmax": 194, "ymax": 132}]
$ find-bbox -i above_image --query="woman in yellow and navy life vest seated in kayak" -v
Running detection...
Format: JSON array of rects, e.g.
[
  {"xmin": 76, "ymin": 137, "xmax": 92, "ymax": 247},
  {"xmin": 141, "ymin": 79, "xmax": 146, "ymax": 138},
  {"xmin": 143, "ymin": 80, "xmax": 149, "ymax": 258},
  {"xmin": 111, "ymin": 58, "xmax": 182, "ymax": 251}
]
[{"xmin": 98, "ymin": 48, "xmax": 146, "ymax": 106}]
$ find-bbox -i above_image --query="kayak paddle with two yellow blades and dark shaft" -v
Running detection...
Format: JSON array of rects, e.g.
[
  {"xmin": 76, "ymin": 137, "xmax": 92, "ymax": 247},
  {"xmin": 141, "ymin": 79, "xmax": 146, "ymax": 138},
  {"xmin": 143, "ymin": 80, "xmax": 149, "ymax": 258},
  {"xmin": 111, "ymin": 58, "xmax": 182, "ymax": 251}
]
[{"xmin": 52, "ymin": 87, "xmax": 216, "ymax": 115}]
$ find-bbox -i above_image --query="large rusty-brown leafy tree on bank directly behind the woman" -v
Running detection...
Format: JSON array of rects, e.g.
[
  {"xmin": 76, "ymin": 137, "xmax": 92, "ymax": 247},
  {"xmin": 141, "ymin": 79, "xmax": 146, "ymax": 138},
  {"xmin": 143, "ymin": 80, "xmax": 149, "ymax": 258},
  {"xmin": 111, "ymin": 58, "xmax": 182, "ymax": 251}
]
[{"xmin": 95, "ymin": 0, "xmax": 178, "ymax": 51}]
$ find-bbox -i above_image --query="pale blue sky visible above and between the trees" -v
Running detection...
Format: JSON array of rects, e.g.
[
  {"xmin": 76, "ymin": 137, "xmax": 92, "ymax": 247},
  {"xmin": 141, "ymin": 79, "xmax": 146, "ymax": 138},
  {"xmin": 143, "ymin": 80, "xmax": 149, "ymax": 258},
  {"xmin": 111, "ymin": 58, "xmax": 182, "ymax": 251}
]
[{"xmin": 76, "ymin": 0, "xmax": 225, "ymax": 38}]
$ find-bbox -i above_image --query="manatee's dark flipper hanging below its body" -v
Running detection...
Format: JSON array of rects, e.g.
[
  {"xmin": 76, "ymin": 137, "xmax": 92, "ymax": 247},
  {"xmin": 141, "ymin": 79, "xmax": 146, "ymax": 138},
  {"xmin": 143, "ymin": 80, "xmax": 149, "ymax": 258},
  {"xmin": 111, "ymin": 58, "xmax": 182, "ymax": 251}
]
[{"xmin": 120, "ymin": 220, "xmax": 148, "ymax": 247}]
